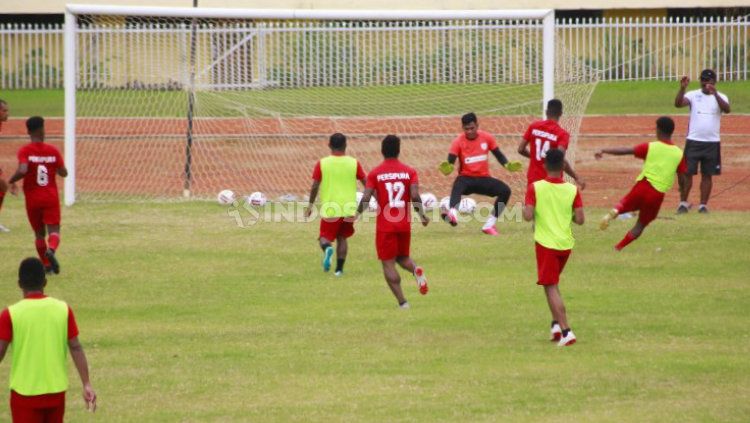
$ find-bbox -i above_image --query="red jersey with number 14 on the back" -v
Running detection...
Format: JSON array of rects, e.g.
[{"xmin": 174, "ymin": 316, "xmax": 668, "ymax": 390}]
[{"xmin": 523, "ymin": 119, "xmax": 570, "ymax": 184}]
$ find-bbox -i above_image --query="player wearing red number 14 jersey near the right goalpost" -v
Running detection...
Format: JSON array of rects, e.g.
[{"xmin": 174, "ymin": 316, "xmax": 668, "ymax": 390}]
[{"xmin": 518, "ymin": 99, "xmax": 586, "ymax": 189}]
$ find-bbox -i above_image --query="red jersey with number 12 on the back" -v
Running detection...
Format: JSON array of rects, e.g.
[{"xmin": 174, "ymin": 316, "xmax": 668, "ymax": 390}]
[{"xmin": 366, "ymin": 159, "xmax": 419, "ymax": 232}]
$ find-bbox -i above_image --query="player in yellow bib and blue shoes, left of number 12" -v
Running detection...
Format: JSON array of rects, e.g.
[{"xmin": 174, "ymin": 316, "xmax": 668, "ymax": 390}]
[{"xmin": 305, "ymin": 133, "xmax": 366, "ymax": 276}]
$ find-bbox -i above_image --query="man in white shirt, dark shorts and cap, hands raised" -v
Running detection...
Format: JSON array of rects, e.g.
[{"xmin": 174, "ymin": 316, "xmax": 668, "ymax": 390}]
[{"xmin": 674, "ymin": 69, "xmax": 729, "ymax": 214}]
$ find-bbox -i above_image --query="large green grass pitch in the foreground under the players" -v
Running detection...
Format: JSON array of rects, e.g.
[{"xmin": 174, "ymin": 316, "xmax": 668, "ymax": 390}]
[{"xmin": 0, "ymin": 204, "xmax": 750, "ymax": 422}]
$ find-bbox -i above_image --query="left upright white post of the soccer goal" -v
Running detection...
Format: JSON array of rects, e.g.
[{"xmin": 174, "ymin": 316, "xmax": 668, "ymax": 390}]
[{"xmin": 63, "ymin": 10, "xmax": 78, "ymax": 206}]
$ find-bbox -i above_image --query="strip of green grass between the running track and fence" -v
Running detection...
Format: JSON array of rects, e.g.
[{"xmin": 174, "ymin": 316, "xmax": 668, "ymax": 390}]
[{"xmin": 0, "ymin": 81, "xmax": 750, "ymax": 117}]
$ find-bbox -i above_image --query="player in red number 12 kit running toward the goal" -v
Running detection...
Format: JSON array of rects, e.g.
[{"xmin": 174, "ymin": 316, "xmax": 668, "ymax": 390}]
[{"xmin": 357, "ymin": 135, "xmax": 430, "ymax": 309}]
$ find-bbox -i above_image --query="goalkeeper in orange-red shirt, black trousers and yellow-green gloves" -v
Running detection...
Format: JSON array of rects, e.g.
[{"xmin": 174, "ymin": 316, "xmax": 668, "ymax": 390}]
[{"xmin": 439, "ymin": 113, "xmax": 521, "ymax": 236}]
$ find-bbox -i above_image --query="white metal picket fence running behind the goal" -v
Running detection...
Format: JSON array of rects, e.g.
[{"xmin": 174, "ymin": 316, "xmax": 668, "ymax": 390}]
[{"xmin": 0, "ymin": 17, "xmax": 750, "ymax": 89}]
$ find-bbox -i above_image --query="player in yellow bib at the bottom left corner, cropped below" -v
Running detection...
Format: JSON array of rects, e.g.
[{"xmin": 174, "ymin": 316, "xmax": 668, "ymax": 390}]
[{"xmin": 0, "ymin": 258, "xmax": 96, "ymax": 423}]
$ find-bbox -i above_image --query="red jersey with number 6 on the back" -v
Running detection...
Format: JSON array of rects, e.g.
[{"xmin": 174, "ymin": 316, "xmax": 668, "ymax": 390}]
[{"xmin": 18, "ymin": 142, "xmax": 65, "ymax": 203}]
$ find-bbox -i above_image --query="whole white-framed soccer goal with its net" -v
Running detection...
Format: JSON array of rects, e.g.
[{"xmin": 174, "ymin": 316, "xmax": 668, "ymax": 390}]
[{"xmin": 65, "ymin": 5, "xmax": 596, "ymax": 205}]
